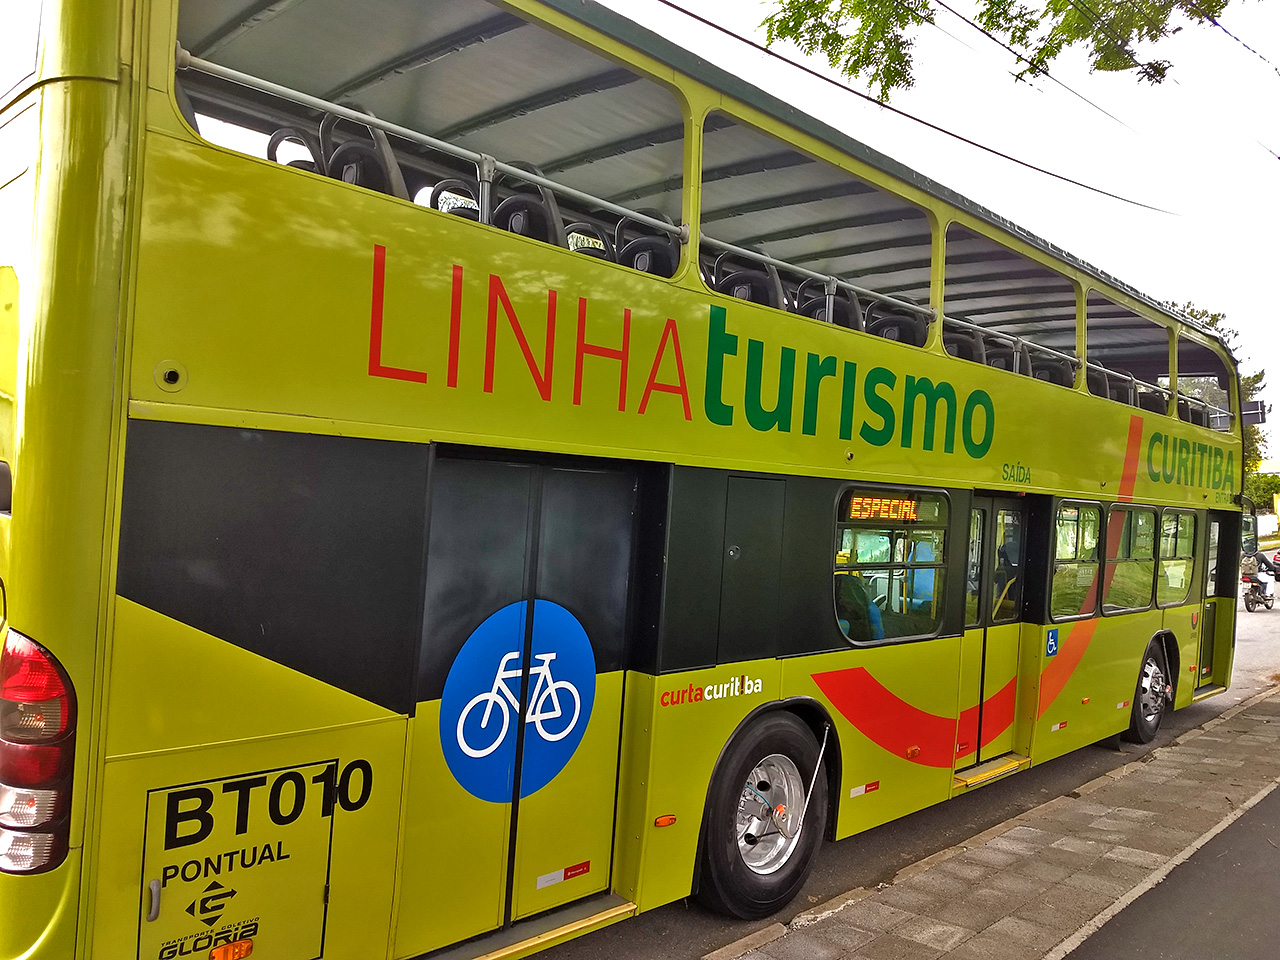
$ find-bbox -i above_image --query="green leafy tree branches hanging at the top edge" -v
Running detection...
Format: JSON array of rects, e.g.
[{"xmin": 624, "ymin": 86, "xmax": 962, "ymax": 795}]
[{"xmin": 764, "ymin": 0, "xmax": 1229, "ymax": 101}]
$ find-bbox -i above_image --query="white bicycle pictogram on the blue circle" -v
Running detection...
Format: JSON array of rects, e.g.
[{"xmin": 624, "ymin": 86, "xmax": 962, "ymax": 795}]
[{"xmin": 458, "ymin": 652, "xmax": 582, "ymax": 759}]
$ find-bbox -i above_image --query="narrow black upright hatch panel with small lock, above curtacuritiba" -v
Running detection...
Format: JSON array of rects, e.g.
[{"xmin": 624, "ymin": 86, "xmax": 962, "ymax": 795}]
[{"xmin": 658, "ymin": 467, "xmax": 728, "ymax": 673}]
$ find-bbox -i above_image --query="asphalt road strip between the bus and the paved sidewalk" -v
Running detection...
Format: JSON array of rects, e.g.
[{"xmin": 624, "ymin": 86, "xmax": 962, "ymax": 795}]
[{"xmin": 540, "ymin": 603, "xmax": 1280, "ymax": 960}]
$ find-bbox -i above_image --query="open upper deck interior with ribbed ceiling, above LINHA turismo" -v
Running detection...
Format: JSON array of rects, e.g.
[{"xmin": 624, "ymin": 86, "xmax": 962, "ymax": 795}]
[{"xmin": 178, "ymin": 0, "xmax": 1231, "ymax": 430}]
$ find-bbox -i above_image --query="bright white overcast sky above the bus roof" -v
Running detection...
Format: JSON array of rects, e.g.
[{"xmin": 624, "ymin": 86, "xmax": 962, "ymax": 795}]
[{"xmin": 602, "ymin": 0, "xmax": 1280, "ymax": 457}]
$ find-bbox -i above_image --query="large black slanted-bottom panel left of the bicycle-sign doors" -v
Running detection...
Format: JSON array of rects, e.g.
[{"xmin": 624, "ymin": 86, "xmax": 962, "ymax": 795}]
[{"xmin": 116, "ymin": 420, "xmax": 429, "ymax": 713}]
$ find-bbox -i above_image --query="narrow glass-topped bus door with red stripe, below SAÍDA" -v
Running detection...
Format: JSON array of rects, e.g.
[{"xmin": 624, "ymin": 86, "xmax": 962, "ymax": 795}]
[{"xmin": 956, "ymin": 497, "xmax": 1025, "ymax": 767}]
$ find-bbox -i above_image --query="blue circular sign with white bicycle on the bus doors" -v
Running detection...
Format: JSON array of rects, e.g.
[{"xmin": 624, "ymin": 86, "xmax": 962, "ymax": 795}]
[{"xmin": 440, "ymin": 600, "xmax": 595, "ymax": 804}]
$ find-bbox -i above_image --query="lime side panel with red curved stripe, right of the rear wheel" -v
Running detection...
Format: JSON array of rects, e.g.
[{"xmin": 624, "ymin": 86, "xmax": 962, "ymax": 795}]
[{"xmin": 782, "ymin": 636, "xmax": 961, "ymax": 838}]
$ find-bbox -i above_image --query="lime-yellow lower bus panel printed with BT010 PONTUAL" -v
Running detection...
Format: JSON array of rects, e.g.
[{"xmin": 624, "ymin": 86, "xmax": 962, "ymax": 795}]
[{"xmin": 91, "ymin": 718, "xmax": 404, "ymax": 960}]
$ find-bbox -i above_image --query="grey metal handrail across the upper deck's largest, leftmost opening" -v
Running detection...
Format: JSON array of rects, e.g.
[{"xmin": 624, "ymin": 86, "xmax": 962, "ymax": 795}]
[{"xmin": 177, "ymin": 46, "xmax": 690, "ymax": 243}]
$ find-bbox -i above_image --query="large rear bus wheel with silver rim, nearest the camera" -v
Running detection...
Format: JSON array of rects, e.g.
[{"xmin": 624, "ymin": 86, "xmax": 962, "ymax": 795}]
[{"xmin": 698, "ymin": 710, "xmax": 827, "ymax": 920}]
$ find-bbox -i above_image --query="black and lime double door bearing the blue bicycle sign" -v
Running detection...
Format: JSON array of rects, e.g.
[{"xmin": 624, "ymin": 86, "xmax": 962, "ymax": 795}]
[{"xmin": 396, "ymin": 456, "xmax": 637, "ymax": 956}]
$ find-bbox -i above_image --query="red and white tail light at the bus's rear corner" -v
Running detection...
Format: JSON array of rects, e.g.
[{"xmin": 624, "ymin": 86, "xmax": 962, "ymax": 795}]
[{"xmin": 0, "ymin": 630, "xmax": 76, "ymax": 873}]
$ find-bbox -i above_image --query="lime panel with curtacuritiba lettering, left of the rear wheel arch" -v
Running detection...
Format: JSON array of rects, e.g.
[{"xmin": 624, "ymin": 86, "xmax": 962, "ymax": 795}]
[{"xmin": 628, "ymin": 659, "xmax": 781, "ymax": 910}]
